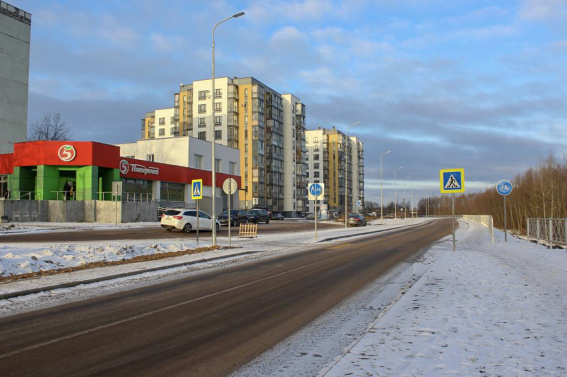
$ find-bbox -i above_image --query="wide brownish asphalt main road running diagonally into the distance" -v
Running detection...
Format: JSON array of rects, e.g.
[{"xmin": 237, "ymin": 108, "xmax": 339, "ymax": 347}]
[{"xmin": 0, "ymin": 219, "xmax": 451, "ymax": 377}]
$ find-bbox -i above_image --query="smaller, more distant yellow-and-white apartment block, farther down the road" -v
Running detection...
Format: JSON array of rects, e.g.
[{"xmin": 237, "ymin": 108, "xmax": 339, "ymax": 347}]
[{"xmin": 305, "ymin": 127, "xmax": 364, "ymax": 213}]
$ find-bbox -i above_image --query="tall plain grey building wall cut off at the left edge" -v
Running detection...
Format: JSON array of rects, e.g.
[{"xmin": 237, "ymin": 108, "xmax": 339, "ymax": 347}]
[{"xmin": 0, "ymin": 1, "xmax": 31, "ymax": 153}]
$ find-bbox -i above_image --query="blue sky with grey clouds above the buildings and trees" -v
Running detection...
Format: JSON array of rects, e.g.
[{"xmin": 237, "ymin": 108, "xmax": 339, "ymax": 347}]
[{"xmin": 9, "ymin": 0, "xmax": 567, "ymax": 202}]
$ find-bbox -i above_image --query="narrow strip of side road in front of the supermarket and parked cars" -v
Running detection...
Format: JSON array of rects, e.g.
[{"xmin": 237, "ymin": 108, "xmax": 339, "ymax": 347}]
[{"xmin": 0, "ymin": 221, "xmax": 344, "ymax": 242}]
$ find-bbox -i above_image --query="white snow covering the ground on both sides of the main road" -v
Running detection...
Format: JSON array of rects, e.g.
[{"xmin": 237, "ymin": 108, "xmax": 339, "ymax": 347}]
[{"xmin": 0, "ymin": 219, "xmax": 567, "ymax": 377}]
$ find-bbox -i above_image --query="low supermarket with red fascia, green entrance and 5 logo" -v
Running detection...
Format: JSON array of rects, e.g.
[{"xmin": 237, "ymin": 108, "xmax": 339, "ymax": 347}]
[{"xmin": 0, "ymin": 137, "xmax": 240, "ymax": 222}]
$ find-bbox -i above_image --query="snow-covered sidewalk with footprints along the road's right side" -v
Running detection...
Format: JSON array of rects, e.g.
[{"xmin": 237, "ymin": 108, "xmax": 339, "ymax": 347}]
[{"xmin": 319, "ymin": 222, "xmax": 567, "ymax": 377}]
